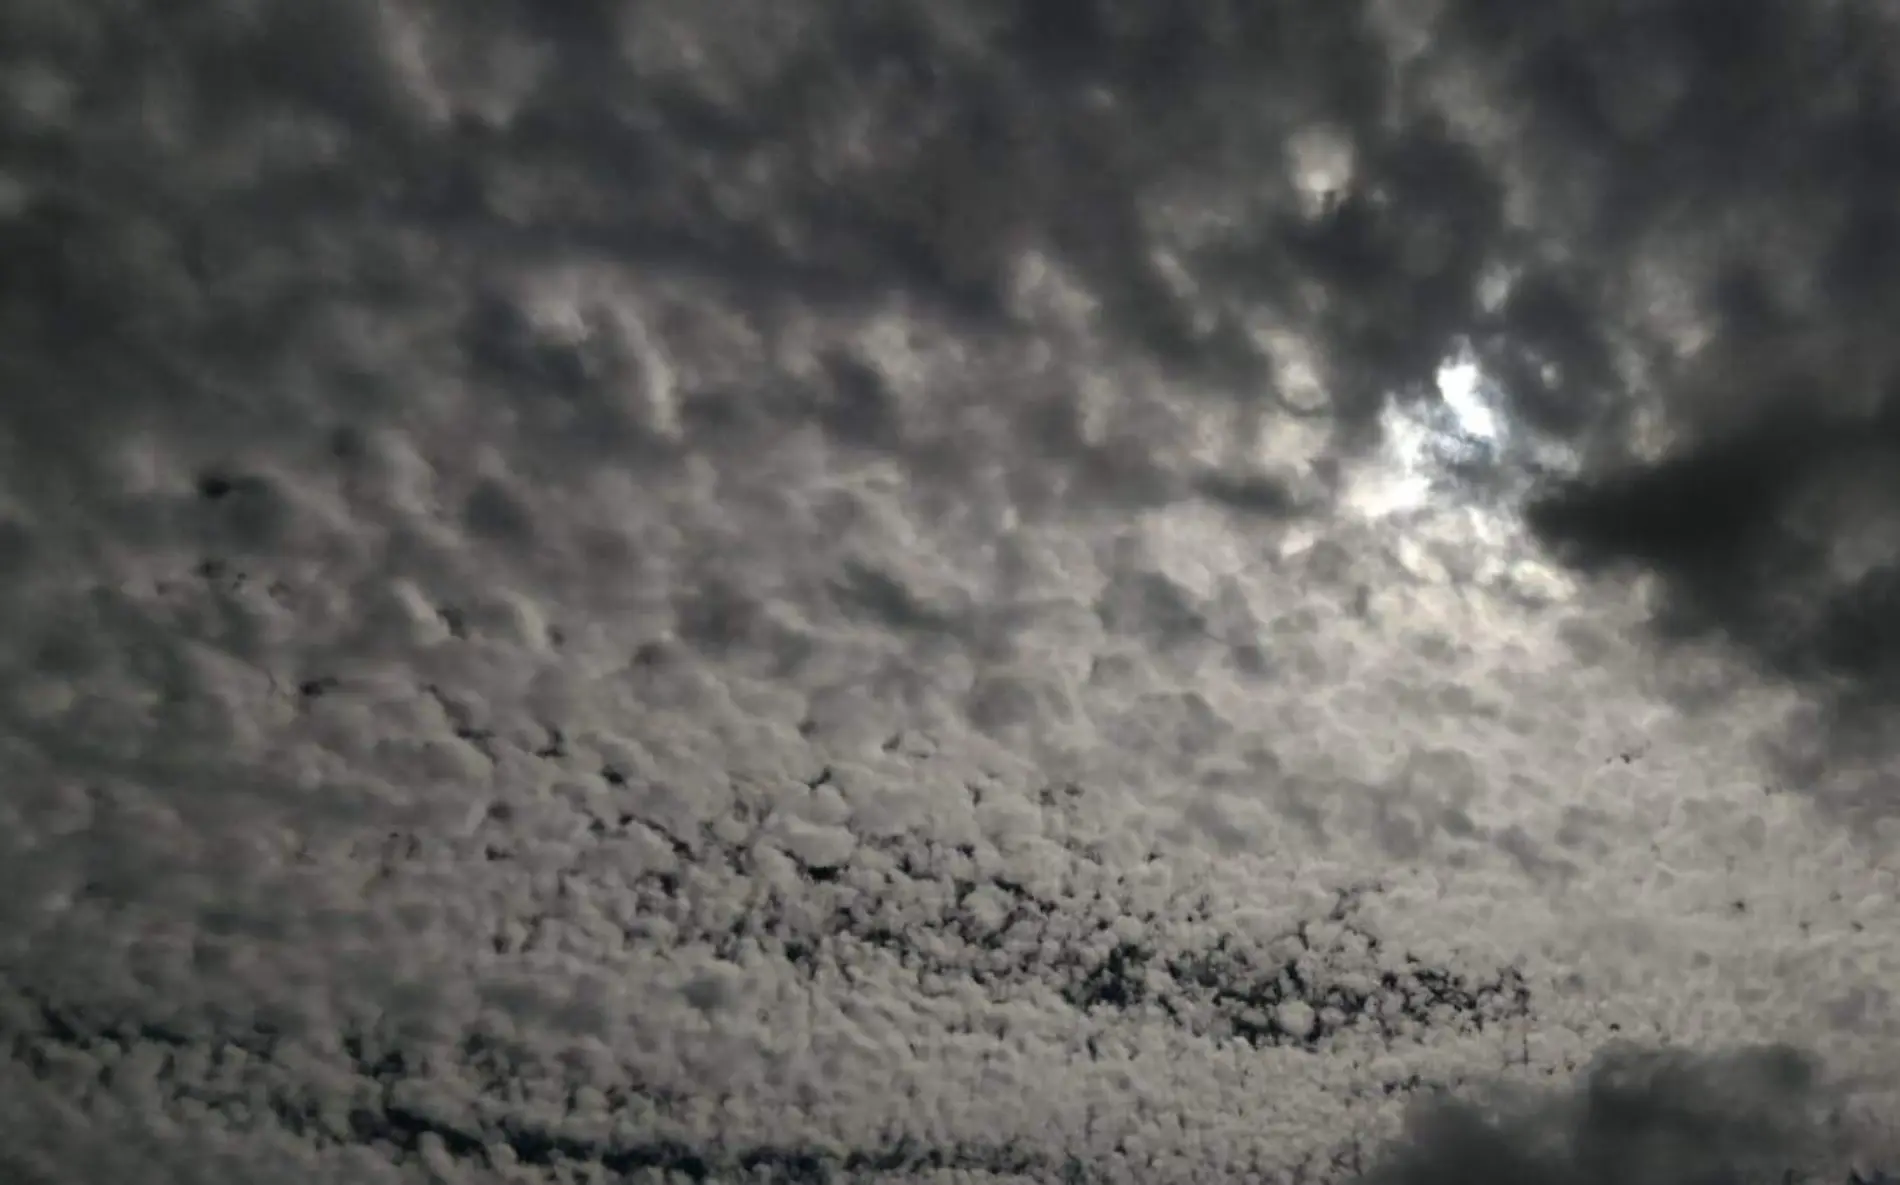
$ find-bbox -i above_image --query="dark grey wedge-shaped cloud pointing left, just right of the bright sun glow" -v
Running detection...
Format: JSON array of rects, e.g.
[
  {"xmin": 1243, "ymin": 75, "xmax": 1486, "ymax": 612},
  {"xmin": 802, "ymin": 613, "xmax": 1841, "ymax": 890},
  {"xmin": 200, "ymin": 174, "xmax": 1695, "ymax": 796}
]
[{"xmin": 1528, "ymin": 368, "xmax": 1900, "ymax": 813}]
